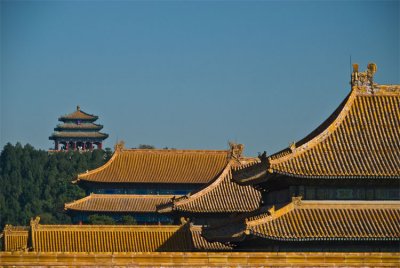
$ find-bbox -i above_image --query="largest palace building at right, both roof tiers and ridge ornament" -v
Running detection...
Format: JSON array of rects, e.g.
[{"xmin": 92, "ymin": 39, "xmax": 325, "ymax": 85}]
[{"xmin": 203, "ymin": 63, "xmax": 400, "ymax": 252}]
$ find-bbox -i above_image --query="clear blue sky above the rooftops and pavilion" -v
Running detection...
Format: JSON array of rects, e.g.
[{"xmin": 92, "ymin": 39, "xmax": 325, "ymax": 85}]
[{"xmin": 0, "ymin": 0, "xmax": 400, "ymax": 155}]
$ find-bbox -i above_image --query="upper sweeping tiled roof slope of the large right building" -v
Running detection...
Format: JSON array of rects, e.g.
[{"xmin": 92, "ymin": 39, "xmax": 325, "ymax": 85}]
[{"xmin": 269, "ymin": 85, "xmax": 400, "ymax": 178}]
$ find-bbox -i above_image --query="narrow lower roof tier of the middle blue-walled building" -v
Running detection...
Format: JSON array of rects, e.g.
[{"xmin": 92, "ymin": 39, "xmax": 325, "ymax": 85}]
[{"xmin": 65, "ymin": 194, "xmax": 178, "ymax": 212}]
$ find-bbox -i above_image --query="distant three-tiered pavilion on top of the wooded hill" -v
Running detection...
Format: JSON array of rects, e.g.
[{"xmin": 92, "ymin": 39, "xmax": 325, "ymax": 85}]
[{"xmin": 49, "ymin": 106, "xmax": 108, "ymax": 151}]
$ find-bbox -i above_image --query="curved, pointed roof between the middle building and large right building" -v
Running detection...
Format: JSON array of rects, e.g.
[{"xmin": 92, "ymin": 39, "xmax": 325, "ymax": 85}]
[{"xmin": 159, "ymin": 160, "xmax": 261, "ymax": 213}]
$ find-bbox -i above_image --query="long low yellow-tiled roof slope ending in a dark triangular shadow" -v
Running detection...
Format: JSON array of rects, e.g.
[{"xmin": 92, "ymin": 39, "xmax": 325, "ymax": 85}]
[{"xmin": 31, "ymin": 219, "xmax": 193, "ymax": 252}]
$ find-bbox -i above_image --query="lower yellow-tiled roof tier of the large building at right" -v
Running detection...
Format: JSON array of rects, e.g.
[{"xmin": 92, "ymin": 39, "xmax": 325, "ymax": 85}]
[{"xmin": 207, "ymin": 198, "xmax": 400, "ymax": 241}]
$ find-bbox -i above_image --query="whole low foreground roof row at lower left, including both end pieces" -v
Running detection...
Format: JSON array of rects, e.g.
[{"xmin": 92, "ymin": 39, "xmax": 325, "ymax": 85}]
[{"xmin": 3, "ymin": 217, "xmax": 232, "ymax": 252}]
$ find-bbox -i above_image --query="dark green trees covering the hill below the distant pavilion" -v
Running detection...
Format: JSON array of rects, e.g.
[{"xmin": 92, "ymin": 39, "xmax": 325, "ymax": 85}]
[{"xmin": 0, "ymin": 143, "xmax": 111, "ymax": 231}]
